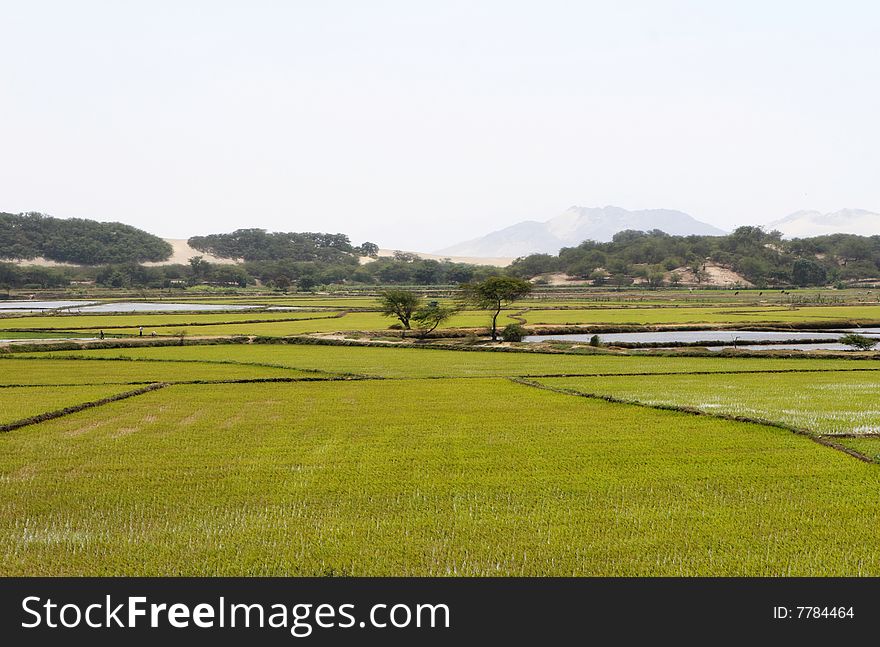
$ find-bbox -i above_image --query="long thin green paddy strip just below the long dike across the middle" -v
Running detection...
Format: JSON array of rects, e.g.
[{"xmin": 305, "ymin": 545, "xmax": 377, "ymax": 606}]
[{"xmin": 29, "ymin": 344, "xmax": 880, "ymax": 378}]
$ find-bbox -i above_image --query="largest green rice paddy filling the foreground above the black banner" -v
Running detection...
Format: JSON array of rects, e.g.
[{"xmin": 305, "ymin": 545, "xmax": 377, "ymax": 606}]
[{"xmin": 0, "ymin": 379, "xmax": 880, "ymax": 575}]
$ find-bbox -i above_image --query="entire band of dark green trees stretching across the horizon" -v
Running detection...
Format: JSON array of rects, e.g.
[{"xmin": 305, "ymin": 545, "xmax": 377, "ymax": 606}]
[{"xmin": 6, "ymin": 220, "xmax": 880, "ymax": 290}]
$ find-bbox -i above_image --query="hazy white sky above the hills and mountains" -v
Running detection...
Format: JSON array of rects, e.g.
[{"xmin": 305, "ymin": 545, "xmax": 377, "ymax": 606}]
[{"xmin": 0, "ymin": 0, "xmax": 880, "ymax": 251}]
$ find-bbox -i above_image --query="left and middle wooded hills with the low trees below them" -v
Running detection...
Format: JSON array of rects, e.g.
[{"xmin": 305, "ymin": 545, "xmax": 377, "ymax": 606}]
[{"xmin": 0, "ymin": 218, "xmax": 508, "ymax": 291}]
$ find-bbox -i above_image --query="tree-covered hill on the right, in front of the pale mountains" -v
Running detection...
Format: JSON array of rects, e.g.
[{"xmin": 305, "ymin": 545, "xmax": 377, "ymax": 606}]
[{"xmin": 510, "ymin": 227, "xmax": 880, "ymax": 286}]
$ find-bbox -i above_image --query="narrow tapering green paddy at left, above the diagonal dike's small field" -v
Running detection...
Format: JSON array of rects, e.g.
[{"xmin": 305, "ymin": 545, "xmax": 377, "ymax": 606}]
[{"xmin": 0, "ymin": 357, "xmax": 314, "ymax": 385}]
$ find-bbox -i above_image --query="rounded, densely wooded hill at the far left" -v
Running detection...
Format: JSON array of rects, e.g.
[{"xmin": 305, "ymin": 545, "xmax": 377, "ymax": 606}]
[{"xmin": 0, "ymin": 213, "xmax": 172, "ymax": 265}]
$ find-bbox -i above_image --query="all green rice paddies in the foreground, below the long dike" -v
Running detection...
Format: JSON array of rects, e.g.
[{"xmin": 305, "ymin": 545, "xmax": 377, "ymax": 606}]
[{"xmin": 0, "ymin": 342, "xmax": 880, "ymax": 576}]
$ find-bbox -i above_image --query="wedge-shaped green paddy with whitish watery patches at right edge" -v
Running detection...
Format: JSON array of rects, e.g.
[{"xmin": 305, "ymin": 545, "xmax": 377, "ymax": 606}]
[{"xmin": 541, "ymin": 371, "xmax": 880, "ymax": 434}]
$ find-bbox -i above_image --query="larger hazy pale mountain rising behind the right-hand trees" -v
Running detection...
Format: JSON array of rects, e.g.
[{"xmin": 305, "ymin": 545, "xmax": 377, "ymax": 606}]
[{"xmin": 437, "ymin": 206, "xmax": 726, "ymax": 257}]
